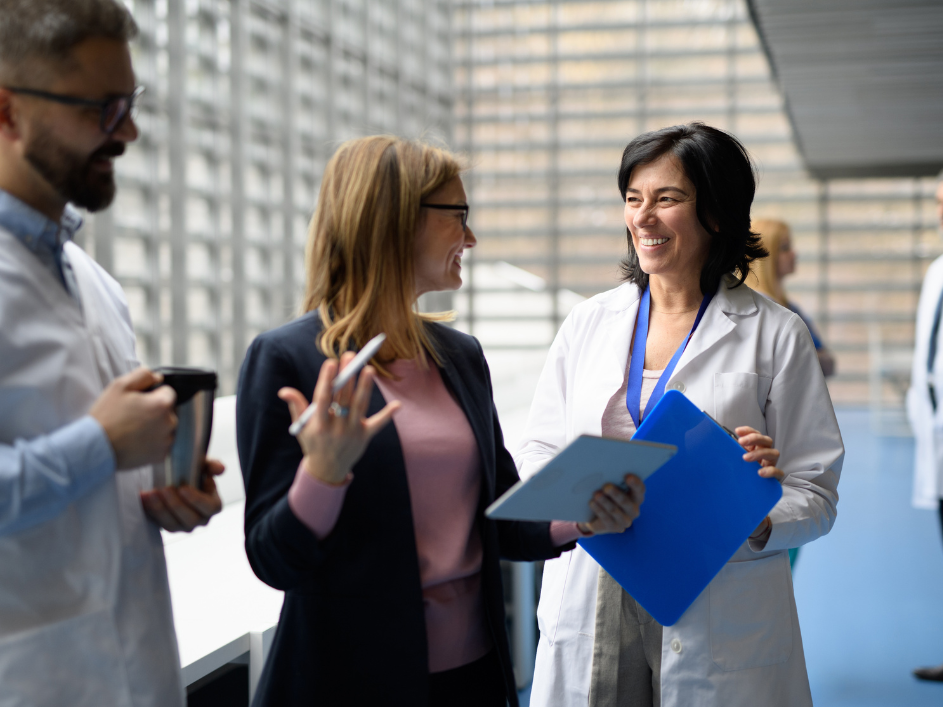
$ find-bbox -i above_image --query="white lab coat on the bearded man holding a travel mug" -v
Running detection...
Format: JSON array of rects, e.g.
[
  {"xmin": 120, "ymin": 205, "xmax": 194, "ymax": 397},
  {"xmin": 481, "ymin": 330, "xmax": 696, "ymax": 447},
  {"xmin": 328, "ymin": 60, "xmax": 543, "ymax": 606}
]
[{"xmin": 0, "ymin": 230, "xmax": 185, "ymax": 707}]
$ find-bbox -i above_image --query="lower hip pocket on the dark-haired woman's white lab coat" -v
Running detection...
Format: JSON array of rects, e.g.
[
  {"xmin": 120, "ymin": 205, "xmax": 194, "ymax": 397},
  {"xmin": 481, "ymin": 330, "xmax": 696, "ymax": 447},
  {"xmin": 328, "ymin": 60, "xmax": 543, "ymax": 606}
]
[{"xmin": 708, "ymin": 552, "xmax": 793, "ymax": 672}]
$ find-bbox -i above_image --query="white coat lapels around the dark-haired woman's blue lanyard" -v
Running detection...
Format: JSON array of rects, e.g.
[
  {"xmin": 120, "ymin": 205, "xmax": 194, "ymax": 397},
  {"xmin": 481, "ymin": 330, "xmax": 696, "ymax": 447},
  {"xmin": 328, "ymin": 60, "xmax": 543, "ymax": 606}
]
[{"xmin": 592, "ymin": 275, "xmax": 757, "ymax": 380}]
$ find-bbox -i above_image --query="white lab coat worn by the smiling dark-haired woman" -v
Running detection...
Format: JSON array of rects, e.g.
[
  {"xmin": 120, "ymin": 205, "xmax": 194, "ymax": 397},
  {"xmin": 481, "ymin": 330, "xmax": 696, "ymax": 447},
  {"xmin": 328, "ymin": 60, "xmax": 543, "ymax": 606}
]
[{"xmin": 518, "ymin": 281, "xmax": 844, "ymax": 707}]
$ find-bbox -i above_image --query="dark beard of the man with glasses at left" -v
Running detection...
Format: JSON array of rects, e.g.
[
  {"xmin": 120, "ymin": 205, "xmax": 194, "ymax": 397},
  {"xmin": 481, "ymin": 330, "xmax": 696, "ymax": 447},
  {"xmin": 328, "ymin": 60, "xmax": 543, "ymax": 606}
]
[{"xmin": 26, "ymin": 125, "xmax": 124, "ymax": 211}]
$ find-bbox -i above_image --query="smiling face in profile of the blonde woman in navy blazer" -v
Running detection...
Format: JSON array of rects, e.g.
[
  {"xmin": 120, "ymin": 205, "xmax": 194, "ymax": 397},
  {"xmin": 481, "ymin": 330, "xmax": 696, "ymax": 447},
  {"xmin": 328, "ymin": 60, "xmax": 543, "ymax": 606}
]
[{"xmin": 413, "ymin": 177, "xmax": 478, "ymax": 297}]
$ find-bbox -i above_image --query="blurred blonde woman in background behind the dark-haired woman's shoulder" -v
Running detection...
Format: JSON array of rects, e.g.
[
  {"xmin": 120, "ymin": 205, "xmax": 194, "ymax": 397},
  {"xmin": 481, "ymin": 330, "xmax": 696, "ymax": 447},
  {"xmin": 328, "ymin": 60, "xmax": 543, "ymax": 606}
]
[{"xmin": 747, "ymin": 219, "xmax": 835, "ymax": 378}]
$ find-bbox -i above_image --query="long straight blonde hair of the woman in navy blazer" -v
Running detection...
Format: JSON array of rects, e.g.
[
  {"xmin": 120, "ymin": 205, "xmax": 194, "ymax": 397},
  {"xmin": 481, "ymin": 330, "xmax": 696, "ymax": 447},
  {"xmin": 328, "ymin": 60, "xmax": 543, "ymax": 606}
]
[{"xmin": 302, "ymin": 135, "xmax": 461, "ymax": 375}]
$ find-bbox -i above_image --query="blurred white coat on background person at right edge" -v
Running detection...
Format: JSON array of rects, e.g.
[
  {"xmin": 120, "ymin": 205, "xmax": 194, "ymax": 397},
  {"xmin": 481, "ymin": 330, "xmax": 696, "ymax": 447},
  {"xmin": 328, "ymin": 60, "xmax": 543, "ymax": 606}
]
[{"xmin": 907, "ymin": 257, "xmax": 943, "ymax": 510}]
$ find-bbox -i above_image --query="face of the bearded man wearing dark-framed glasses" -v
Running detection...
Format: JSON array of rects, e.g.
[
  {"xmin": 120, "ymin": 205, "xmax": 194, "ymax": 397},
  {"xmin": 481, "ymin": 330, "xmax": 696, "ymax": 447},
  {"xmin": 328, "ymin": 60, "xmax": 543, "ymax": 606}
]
[{"xmin": 17, "ymin": 38, "xmax": 138, "ymax": 211}]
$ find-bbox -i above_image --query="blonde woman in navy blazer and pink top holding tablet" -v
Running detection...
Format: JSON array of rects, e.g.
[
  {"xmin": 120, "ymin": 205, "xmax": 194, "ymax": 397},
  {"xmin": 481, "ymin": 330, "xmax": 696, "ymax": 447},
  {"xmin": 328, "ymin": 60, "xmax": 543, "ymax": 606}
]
[{"xmin": 237, "ymin": 137, "xmax": 644, "ymax": 707}]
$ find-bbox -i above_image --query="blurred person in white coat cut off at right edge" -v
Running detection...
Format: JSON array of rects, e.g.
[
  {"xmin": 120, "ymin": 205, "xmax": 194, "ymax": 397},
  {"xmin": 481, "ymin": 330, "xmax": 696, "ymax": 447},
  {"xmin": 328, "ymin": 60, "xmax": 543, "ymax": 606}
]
[{"xmin": 907, "ymin": 175, "xmax": 943, "ymax": 682}]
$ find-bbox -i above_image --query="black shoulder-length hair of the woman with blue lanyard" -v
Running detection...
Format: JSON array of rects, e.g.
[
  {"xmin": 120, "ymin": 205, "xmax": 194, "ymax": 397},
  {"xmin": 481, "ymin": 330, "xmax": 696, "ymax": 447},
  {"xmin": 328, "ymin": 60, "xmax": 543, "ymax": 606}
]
[{"xmin": 619, "ymin": 122, "xmax": 768, "ymax": 294}]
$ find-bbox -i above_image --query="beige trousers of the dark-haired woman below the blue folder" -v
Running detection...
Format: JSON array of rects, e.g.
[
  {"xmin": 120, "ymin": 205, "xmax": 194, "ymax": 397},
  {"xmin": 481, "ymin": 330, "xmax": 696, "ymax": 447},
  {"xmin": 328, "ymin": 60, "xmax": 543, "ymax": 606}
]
[{"xmin": 589, "ymin": 567, "xmax": 662, "ymax": 707}]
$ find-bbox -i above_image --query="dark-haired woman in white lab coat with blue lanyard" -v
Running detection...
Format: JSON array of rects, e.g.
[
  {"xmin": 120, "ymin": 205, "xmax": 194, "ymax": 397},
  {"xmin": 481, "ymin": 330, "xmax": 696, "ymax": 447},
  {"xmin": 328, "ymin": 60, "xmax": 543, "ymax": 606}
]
[{"xmin": 518, "ymin": 123, "xmax": 844, "ymax": 707}]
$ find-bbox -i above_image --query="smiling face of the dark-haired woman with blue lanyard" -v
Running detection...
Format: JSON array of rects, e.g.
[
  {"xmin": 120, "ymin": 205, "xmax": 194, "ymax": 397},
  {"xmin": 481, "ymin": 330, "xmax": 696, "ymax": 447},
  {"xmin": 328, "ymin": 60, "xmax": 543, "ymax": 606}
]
[{"xmin": 625, "ymin": 155, "xmax": 711, "ymax": 290}]
